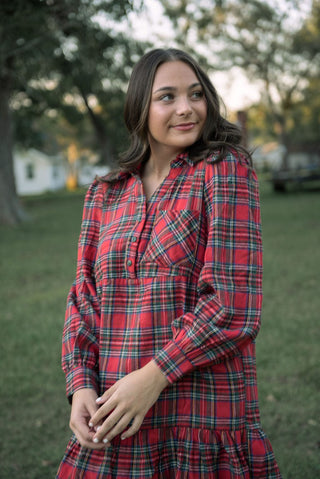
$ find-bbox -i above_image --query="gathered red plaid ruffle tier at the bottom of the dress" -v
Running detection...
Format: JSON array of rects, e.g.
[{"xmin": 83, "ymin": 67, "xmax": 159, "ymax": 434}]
[{"xmin": 57, "ymin": 427, "xmax": 281, "ymax": 479}]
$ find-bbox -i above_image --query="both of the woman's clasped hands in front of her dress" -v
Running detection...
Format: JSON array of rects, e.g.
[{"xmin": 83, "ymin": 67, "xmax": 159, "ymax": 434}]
[{"xmin": 70, "ymin": 361, "xmax": 169, "ymax": 449}]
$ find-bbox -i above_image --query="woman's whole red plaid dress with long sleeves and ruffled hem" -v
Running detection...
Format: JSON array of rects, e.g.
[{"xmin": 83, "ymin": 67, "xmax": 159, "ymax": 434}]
[{"xmin": 57, "ymin": 154, "xmax": 281, "ymax": 479}]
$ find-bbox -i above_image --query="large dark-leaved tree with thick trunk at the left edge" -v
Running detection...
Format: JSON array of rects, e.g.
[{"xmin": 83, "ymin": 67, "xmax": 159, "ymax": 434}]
[{"xmin": 0, "ymin": 0, "xmax": 145, "ymax": 224}]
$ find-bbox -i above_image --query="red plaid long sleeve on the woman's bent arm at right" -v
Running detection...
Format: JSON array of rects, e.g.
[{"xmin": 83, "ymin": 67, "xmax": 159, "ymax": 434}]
[{"xmin": 154, "ymin": 155, "xmax": 262, "ymax": 382}]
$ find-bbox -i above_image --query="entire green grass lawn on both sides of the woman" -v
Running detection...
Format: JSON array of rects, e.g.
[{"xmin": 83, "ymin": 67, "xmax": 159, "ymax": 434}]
[{"xmin": 0, "ymin": 184, "xmax": 320, "ymax": 479}]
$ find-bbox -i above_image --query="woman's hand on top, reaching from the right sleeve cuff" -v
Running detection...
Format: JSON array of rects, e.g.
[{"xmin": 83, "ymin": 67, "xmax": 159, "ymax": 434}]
[{"xmin": 89, "ymin": 361, "xmax": 169, "ymax": 447}]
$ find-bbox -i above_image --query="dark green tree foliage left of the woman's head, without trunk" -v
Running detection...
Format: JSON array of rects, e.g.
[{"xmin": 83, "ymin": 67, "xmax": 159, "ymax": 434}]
[{"xmin": 1, "ymin": 0, "xmax": 146, "ymax": 162}]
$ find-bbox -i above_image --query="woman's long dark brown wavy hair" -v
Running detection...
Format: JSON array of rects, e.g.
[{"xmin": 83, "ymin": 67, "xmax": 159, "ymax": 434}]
[{"xmin": 105, "ymin": 48, "xmax": 251, "ymax": 180}]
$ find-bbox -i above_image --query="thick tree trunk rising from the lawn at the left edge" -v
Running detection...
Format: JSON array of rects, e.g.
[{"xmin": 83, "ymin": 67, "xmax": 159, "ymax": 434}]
[{"xmin": 0, "ymin": 65, "xmax": 27, "ymax": 225}]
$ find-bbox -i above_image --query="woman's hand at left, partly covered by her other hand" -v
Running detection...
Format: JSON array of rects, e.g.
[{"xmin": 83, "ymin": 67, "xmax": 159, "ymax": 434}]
[{"xmin": 69, "ymin": 388, "xmax": 105, "ymax": 449}]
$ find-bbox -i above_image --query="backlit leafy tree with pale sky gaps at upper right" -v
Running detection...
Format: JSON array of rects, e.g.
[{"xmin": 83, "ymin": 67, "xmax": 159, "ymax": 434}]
[{"xmin": 162, "ymin": 0, "xmax": 320, "ymax": 168}]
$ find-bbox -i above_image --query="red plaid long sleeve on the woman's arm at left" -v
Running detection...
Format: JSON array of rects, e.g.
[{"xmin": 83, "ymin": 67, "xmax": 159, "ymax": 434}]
[{"xmin": 62, "ymin": 182, "xmax": 102, "ymax": 396}]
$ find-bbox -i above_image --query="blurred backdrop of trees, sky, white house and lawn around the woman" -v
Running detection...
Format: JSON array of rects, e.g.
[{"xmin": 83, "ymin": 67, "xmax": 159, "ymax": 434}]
[{"xmin": 0, "ymin": 0, "xmax": 320, "ymax": 479}]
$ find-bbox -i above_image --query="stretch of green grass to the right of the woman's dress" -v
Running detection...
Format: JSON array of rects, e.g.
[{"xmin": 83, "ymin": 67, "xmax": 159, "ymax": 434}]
[{"xmin": 257, "ymin": 185, "xmax": 320, "ymax": 479}]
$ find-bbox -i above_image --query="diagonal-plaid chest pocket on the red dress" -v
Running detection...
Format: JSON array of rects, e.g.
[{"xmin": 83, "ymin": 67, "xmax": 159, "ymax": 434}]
[{"xmin": 142, "ymin": 210, "xmax": 200, "ymax": 267}]
